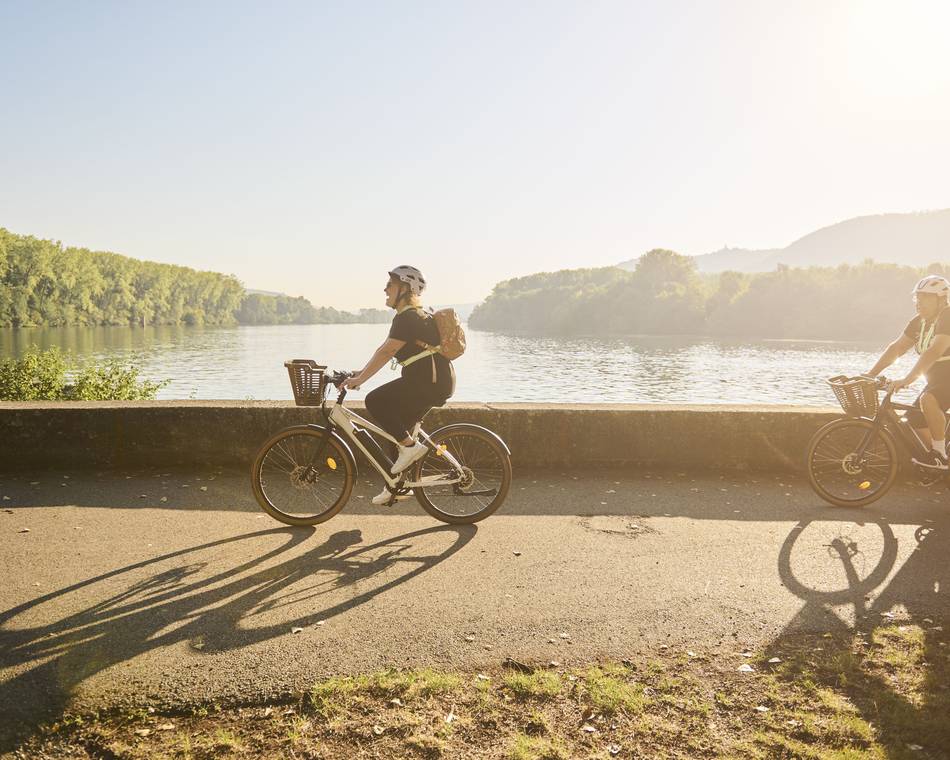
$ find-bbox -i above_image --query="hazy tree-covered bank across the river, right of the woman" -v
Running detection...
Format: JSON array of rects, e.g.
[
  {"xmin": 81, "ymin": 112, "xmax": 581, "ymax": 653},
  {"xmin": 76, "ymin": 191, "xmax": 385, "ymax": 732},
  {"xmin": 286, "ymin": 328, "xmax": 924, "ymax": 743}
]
[{"xmin": 469, "ymin": 249, "xmax": 950, "ymax": 341}]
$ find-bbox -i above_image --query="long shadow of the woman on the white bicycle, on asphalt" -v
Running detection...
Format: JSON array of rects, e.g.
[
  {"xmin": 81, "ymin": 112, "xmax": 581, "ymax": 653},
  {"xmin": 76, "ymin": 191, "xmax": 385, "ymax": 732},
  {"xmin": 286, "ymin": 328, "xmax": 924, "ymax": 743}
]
[{"xmin": 0, "ymin": 525, "xmax": 477, "ymax": 753}]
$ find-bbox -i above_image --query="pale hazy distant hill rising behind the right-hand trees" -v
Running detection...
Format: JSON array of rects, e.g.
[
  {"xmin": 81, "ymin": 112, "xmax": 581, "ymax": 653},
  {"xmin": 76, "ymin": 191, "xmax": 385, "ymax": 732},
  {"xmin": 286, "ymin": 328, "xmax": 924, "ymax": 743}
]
[{"xmin": 618, "ymin": 209, "xmax": 950, "ymax": 272}]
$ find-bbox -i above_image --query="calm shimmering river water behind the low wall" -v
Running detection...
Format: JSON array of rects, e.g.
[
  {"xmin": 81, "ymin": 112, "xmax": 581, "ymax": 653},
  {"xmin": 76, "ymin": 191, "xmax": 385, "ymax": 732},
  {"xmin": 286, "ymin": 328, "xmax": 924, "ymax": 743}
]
[{"xmin": 0, "ymin": 325, "xmax": 913, "ymax": 405}]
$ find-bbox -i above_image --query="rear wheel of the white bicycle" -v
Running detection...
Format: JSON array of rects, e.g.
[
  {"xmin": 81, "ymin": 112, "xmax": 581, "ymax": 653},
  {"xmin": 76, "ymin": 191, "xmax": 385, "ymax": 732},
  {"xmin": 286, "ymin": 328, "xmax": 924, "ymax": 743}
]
[{"xmin": 413, "ymin": 424, "xmax": 511, "ymax": 524}]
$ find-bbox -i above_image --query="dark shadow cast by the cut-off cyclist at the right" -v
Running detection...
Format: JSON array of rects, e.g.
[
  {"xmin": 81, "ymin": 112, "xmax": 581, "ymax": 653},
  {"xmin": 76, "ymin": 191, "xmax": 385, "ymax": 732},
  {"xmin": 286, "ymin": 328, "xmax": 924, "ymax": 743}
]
[{"xmin": 770, "ymin": 508, "xmax": 950, "ymax": 757}]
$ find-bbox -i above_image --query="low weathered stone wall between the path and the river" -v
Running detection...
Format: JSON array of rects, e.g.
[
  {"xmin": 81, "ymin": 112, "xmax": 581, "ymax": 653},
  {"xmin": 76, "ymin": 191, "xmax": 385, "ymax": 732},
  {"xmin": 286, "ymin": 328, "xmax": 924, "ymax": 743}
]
[{"xmin": 0, "ymin": 401, "xmax": 840, "ymax": 472}]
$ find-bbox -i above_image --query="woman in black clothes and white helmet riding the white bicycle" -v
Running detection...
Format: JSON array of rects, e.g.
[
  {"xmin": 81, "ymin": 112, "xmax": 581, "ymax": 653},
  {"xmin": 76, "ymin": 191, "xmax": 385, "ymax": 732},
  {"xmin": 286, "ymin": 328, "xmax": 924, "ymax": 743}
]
[{"xmin": 345, "ymin": 266, "xmax": 455, "ymax": 504}]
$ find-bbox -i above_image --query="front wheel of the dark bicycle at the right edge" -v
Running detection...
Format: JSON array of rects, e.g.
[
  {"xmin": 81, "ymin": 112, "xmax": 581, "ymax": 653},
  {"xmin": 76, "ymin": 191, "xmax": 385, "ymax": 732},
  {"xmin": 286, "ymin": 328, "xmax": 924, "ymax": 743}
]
[{"xmin": 807, "ymin": 419, "xmax": 897, "ymax": 507}]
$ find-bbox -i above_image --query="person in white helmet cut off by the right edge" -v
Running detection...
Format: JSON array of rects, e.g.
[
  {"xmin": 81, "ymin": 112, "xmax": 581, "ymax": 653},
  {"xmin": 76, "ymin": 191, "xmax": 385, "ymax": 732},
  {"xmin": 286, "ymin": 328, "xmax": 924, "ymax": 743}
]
[{"xmin": 868, "ymin": 275, "xmax": 950, "ymax": 470}]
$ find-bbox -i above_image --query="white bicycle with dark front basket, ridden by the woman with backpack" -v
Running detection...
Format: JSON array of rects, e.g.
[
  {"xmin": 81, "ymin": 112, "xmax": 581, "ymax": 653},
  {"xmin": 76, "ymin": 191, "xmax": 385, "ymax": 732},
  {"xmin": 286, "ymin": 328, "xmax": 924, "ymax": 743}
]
[{"xmin": 251, "ymin": 359, "xmax": 511, "ymax": 525}]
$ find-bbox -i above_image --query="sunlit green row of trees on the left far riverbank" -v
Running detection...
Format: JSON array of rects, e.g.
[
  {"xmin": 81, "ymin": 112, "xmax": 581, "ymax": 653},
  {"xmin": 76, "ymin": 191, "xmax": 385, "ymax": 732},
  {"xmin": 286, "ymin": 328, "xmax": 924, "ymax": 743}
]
[{"xmin": 0, "ymin": 227, "xmax": 391, "ymax": 327}]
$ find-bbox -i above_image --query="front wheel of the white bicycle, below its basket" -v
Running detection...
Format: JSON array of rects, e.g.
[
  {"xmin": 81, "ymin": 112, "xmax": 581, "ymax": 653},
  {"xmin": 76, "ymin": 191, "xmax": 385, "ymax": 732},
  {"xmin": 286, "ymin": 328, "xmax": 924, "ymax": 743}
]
[{"xmin": 251, "ymin": 427, "xmax": 354, "ymax": 525}]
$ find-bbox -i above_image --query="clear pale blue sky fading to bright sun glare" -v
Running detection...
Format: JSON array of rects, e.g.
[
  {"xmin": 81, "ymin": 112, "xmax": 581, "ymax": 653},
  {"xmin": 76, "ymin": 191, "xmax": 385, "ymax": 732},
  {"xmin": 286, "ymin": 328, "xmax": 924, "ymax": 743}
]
[{"xmin": 0, "ymin": 0, "xmax": 950, "ymax": 308}]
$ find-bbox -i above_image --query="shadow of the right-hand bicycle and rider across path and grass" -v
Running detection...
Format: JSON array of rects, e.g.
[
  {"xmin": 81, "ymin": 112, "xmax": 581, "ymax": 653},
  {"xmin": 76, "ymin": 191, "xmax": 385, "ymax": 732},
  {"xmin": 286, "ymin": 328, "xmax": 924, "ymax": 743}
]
[{"xmin": 766, "ymin": 519, "xmax": 950, "ymax": 758}]
